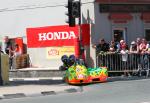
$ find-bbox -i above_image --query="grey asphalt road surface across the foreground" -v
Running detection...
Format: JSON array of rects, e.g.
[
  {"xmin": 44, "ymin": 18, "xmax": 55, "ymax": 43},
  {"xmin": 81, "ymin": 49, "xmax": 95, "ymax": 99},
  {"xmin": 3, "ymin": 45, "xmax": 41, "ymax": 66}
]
[{"xmin": 0, "ymin": 78, "xmax": 150, "ymax": 103}]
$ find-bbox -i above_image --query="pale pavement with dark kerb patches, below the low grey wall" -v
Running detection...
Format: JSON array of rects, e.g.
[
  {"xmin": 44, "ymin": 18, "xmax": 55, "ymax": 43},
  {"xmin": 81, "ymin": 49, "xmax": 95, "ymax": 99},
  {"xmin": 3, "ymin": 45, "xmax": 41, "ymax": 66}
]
[{"xmin": 0, "ymin": 77, "xmax": 80, "ymax": 99}]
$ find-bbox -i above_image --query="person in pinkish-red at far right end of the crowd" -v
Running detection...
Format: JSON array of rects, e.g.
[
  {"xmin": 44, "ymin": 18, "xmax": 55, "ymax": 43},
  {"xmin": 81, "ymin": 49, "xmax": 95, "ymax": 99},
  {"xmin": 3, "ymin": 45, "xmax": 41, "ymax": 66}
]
[{"xmin": 139, "ymin": 38, "xmax": 149, "ymax": 54}]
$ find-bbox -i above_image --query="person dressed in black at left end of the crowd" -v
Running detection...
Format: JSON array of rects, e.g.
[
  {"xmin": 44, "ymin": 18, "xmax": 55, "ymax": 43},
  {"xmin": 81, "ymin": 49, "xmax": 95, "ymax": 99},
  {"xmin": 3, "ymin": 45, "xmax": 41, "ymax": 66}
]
[{"xmin": 94, "ymin": 39, "xmax": 109, "ymax": 53}]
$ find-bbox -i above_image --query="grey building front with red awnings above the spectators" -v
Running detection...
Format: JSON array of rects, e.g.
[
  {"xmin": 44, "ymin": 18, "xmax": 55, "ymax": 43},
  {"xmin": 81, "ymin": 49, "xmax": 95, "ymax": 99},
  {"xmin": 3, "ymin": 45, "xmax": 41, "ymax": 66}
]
[{"xmin": 94, "ymin": 0, "xmax": 150, "ymax": 43}]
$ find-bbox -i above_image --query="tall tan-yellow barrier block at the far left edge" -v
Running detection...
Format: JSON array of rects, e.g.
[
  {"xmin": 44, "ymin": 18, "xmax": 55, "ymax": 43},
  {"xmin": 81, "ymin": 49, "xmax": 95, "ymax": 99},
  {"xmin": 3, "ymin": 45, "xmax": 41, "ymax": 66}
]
[{"xmin": 0, "ymin": 53, "xmax": 9, "ymax": 85}]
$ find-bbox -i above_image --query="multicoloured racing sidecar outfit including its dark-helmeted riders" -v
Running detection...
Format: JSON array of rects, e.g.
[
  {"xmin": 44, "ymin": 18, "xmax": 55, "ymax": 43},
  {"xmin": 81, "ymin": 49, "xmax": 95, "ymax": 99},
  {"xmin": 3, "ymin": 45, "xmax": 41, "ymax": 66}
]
[{"xmin": 61, "ymin": 55, "xmax": 108, "ymax": 84}]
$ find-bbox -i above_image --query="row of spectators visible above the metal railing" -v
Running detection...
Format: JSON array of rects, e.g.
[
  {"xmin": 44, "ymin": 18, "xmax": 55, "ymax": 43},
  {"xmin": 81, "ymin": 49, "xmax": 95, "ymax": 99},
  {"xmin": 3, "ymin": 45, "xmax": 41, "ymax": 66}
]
[{"xmin": 93, "ymin": 35, "xmax": 150, "ymax": 54}]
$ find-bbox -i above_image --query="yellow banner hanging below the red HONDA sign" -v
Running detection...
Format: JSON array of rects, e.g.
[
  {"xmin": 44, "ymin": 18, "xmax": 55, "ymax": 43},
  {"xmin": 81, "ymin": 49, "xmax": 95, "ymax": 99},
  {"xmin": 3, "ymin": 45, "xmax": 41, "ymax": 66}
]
[{"xmin": 46, "ymin": 46, "xmax": 75, "ymax": 59}]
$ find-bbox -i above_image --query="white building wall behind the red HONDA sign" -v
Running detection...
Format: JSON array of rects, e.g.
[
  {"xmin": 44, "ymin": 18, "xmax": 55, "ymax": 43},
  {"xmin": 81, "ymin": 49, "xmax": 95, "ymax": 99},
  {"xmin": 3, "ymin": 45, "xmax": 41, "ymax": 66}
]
[{"xmin": 0, "ymin": 0, "xmax": 94, "ymax": 69}]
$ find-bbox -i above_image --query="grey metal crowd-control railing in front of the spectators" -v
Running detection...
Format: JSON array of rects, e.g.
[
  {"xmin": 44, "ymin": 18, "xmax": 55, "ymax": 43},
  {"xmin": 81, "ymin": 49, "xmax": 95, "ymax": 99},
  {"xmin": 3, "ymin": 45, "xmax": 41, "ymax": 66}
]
[{"xmin": 96, "ymin": 53, "xmax": 150, "ymax": 72}]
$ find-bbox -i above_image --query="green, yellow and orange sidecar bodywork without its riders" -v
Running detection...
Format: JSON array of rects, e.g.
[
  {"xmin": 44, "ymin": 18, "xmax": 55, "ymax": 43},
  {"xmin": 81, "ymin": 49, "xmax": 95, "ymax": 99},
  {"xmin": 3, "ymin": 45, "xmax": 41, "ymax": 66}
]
[{"xmin": 65, "ymin": 65, "xmax": 108, "ymax": 84}]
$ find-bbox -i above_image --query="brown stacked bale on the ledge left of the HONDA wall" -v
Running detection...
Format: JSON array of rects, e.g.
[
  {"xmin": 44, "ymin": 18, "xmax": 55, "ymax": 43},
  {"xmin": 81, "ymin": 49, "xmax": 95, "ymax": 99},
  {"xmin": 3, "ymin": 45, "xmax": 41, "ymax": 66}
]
[{"xmin": 13, "ymin": 54, "xmax": 29, "ymax": 69}]
